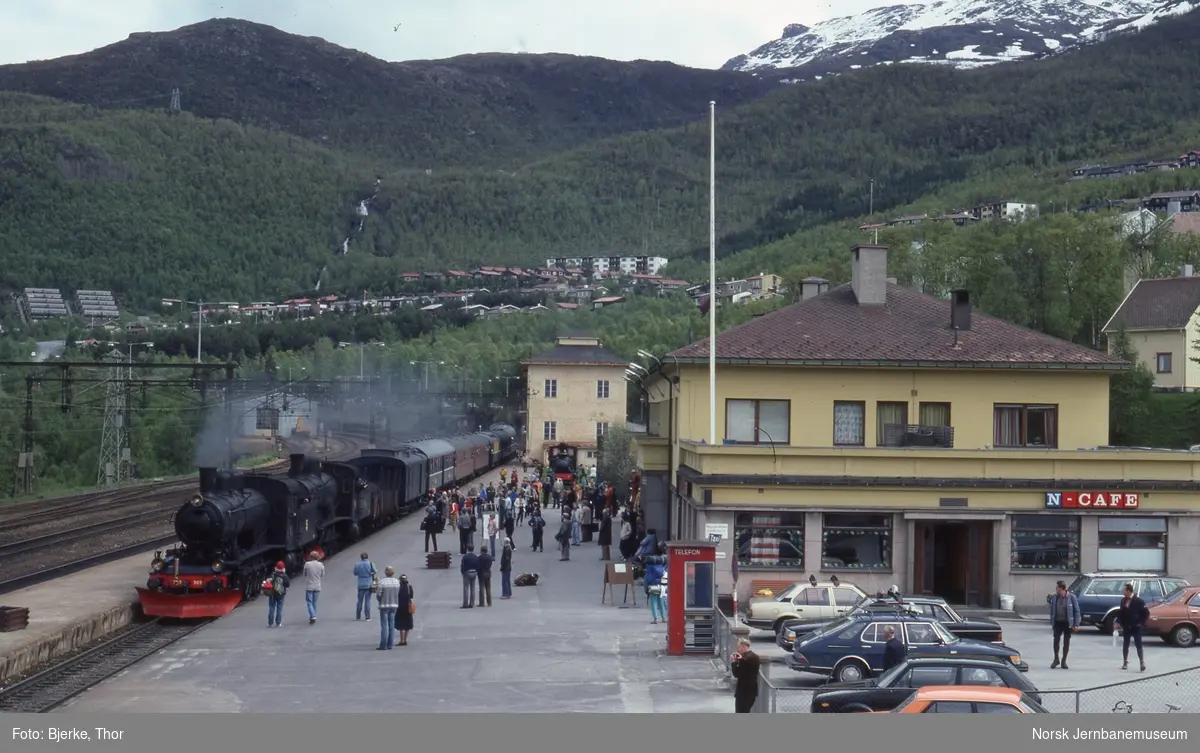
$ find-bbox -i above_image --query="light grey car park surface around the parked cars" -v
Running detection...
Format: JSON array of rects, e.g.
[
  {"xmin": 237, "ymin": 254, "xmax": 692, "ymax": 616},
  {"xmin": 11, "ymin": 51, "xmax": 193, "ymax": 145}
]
[{"xmin": 754, "ymin": 620, "xmax": 1200, "ymax": 713}]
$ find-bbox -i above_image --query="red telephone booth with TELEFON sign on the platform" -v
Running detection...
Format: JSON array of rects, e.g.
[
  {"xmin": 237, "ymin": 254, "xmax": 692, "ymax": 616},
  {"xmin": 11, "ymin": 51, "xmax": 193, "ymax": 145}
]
[{"xmin": 667, "ymin": 541, "xmax": 716, "ymax": 656}]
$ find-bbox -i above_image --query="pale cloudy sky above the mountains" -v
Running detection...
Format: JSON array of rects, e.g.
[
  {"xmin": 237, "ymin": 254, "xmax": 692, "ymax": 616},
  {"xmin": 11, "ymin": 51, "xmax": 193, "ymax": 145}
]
[{"xmin": 0, "ymin": 0, "xmax": 892, "ymax": 68}]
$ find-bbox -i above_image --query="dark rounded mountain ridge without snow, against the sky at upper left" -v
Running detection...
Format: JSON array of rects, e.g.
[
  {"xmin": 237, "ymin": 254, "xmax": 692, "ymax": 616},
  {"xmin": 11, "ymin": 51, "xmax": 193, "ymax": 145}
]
[{"xmin": 0, "ymin": 19, "xmax": 778, "ymax": 169}]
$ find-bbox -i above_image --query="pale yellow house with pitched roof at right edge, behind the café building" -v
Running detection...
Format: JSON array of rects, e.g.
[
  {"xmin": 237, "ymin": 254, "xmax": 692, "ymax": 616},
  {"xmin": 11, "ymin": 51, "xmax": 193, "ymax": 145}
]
[{"xmin": 1103, "ymin": 265, "xmax": 1200, "ymax": 392}]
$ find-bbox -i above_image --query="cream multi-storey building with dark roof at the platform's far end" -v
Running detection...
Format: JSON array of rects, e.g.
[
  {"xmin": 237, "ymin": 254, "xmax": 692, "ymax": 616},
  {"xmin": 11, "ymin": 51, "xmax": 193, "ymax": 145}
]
[{"xmin": 521, "ymin": 335, "xmax": 629, "ymax": 463}]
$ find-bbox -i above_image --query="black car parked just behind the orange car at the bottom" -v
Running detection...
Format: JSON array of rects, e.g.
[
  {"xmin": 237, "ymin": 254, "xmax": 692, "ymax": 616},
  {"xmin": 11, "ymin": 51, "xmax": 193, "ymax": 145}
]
[{"xmin": 810, "ymin": 656, "xmax": 1042, "ymax": 713}]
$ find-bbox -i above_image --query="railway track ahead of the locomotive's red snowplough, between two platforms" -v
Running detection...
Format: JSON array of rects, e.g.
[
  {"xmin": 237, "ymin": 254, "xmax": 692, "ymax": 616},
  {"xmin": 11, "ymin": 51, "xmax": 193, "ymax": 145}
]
[{"xmin": 0, "ymin": 620, "xmax": 211, "ymax": 713}]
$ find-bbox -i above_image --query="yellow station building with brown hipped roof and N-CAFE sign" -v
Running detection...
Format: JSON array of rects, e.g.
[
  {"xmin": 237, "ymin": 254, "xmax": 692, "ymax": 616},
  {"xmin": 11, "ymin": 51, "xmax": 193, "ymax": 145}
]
[{"xmin": 637, "ymin": 246, "xmax": 1200, "ymax": 610}]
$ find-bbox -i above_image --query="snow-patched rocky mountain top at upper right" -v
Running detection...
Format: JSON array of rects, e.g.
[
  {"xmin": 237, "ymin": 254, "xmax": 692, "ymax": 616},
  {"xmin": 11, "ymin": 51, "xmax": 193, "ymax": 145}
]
[{"xmin": 724, "ymin": 0, "xmax": 1163, "ymax": 78}]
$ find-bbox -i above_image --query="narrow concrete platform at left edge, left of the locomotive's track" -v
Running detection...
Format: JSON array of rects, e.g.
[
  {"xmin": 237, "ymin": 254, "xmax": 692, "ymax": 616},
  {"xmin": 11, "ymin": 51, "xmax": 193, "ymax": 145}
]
[{"xmin": 0, "ymin": 552, "xmax": 154, "ymax": 687}]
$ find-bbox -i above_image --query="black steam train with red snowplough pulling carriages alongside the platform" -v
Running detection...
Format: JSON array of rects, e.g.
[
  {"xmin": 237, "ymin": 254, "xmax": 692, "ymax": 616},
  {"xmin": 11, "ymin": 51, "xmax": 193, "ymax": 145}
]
[{"xmin": 137, "ymin": 423, "xmax": 517, "ymax": 618}]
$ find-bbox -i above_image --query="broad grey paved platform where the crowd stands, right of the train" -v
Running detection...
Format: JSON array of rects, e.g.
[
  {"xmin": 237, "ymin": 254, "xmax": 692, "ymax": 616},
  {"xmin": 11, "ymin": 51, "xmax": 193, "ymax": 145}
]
[{"xmin": 62, "ymin": 472, "xmax": 733, "ymax": 713}]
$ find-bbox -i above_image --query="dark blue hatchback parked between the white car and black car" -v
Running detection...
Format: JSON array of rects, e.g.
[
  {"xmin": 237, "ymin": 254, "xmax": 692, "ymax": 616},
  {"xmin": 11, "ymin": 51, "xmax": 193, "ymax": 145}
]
[{"xmin": 787, "ymin": 609, "xmax": 1030, "ymax": 682}]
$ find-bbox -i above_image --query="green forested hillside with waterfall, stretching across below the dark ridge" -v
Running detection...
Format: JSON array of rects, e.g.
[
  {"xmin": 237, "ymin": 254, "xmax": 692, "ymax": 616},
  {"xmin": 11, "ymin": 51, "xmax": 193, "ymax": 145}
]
[{"xmin": 7, "ymin": 8, "xmax": 1200, "ymax": 300}]
